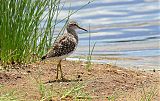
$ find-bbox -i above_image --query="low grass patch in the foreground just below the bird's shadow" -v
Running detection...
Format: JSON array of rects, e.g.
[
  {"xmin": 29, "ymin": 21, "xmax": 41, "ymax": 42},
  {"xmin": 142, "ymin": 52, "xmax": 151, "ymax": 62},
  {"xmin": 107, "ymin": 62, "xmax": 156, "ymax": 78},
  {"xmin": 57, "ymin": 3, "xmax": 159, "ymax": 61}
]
[{"xmin": 32, "ymin": 77, "xmax": 92, "ymax": 101}]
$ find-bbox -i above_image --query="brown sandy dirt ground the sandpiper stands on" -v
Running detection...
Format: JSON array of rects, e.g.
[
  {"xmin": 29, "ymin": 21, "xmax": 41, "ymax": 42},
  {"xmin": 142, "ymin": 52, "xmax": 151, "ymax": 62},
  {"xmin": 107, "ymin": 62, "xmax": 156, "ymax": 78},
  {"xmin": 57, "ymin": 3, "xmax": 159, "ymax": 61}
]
[{"xmin": 0, "ymin": 61, "xmax": 160, "ymax": 101}]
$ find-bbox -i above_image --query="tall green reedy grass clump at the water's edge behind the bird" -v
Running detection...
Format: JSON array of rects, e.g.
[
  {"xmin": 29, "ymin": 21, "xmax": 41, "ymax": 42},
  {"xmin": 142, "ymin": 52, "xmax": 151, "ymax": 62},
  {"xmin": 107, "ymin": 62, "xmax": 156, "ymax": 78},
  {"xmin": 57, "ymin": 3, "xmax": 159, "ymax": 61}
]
[{"xmin": 0, "ymin": 0, "xmax": 94, "ymax": 64}]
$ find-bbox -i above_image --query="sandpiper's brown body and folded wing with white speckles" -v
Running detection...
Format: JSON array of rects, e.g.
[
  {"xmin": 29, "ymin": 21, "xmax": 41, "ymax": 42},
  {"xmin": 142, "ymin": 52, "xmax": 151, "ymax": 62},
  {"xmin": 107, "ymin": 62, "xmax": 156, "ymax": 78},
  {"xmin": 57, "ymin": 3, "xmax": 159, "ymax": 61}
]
[{"xmin": 42, "ymin": 33, "xmax": 78, "ymax": 60}]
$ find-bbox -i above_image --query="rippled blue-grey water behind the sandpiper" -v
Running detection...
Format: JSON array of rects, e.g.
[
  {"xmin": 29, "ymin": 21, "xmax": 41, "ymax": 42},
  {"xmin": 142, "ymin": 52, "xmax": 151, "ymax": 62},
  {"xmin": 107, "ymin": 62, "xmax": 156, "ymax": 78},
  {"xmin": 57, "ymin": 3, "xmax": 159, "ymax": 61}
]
[{"xmin": 55, "ymin": 0, "xmax": 160, "ymax": 69}]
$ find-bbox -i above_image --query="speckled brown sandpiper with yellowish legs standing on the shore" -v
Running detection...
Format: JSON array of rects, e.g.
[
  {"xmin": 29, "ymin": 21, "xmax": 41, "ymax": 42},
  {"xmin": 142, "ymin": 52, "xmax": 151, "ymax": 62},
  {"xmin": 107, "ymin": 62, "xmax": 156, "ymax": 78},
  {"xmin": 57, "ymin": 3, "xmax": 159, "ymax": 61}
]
[{"xmin": 42, "ymin": 21, "xmax": 87, "ymax": 81}]
